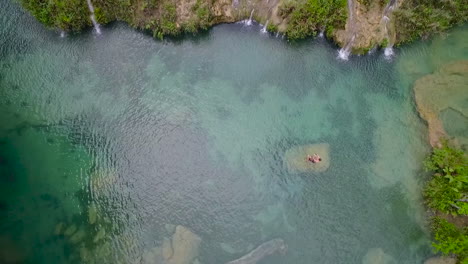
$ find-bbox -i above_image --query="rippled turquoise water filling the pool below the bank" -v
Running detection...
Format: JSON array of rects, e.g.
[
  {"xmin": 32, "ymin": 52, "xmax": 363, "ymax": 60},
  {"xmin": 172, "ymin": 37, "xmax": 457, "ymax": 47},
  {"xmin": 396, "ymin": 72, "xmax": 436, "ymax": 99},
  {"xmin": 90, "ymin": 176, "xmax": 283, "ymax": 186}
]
[{"xmin": 0, "ymin": 1, "xmax": 468, "ymax": 264}]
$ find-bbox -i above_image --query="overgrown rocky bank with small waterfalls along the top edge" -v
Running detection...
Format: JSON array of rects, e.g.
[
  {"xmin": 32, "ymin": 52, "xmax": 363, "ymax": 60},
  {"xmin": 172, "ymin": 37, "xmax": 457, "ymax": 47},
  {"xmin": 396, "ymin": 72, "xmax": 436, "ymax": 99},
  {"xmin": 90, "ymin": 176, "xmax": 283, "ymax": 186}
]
[{"xmin": 19, "ymin": 0, "xmax": 468, "ymax": 54}]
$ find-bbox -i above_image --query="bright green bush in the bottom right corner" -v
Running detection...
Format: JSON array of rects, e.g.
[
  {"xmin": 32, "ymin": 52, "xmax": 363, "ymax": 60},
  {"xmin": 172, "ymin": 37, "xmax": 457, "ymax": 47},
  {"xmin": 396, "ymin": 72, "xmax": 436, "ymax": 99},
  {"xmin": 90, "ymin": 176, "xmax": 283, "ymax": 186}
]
[{"xmin": 431, "ymin": 217, "xmax": 468, "ymax": 264}]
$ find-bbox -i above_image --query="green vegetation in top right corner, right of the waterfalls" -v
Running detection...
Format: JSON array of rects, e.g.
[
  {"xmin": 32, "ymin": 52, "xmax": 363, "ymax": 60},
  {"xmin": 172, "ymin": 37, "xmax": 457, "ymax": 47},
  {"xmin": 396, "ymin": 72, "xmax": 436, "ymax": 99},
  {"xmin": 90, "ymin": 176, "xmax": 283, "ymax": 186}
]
[{"xmin": 394, "ymin": 0, "xmax": 468, "ymax": 43}]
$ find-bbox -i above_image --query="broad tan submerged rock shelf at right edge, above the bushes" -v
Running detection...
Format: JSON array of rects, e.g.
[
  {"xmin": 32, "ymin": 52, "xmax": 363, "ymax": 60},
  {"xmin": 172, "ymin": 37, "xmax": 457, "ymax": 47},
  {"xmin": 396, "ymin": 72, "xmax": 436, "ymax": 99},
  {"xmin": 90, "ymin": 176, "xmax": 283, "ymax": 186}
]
[{"xmin": 414, "ymin": 60, "xmax": 468, "ymax": 146}]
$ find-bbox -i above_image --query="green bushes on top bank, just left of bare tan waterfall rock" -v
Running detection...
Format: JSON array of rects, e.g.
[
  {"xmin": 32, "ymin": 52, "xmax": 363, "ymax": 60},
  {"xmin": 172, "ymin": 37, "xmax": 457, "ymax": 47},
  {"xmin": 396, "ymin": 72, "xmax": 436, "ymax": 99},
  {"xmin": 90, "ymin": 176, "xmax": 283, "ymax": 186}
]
[{"xmin": 278, "ymin": 0, "xmax": 347, "ymax": 40}]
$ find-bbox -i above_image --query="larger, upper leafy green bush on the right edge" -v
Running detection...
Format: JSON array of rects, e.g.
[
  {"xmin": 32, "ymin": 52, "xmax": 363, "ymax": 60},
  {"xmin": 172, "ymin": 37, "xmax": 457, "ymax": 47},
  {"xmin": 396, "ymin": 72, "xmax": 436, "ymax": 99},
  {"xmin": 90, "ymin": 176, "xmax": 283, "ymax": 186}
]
[{"xmin": 424, "ymin": 142, "xmax": 468, "ymax": 215}]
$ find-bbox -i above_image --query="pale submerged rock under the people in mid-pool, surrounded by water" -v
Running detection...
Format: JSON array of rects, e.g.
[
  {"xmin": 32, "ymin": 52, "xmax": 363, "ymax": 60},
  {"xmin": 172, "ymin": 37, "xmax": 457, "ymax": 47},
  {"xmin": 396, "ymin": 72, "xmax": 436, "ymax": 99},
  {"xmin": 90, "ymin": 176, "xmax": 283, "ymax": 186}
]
[{"xmin": 284, "ymin": 143, "xmax": 330, "ymax": 173}]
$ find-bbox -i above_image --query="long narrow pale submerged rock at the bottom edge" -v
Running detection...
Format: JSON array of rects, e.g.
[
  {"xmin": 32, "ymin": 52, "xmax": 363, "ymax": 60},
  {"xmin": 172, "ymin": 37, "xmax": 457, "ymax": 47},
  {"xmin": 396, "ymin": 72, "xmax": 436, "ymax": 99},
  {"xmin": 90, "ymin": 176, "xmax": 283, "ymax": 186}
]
[{"xmin": 226, "ymin": 238, "xmax": 287, "ymax": 264}]
